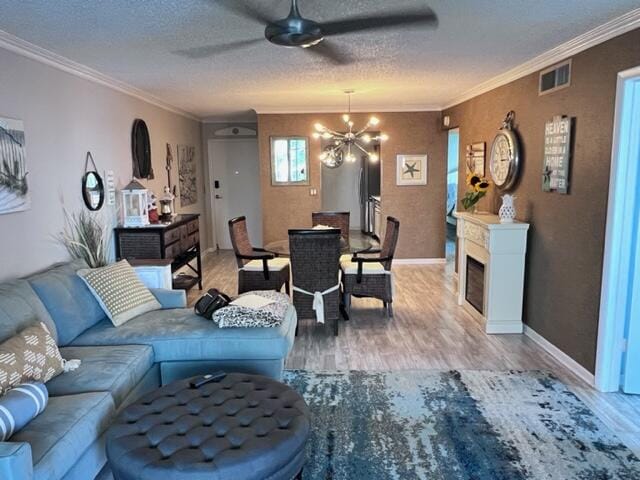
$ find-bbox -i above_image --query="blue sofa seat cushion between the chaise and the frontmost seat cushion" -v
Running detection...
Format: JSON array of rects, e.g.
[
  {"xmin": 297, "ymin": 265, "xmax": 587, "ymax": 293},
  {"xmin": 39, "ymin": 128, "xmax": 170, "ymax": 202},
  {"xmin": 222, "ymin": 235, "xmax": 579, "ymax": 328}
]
[{"xmin": 47, "ymin": 345, "xmax": 153, "ymax": 408}]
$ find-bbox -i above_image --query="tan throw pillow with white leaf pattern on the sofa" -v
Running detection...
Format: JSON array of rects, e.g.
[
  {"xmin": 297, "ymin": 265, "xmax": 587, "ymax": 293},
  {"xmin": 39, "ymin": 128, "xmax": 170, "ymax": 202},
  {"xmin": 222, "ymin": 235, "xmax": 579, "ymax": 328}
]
[{"xmin": 0, "ymin": 322, "xmax": 64, "ymax": 395}]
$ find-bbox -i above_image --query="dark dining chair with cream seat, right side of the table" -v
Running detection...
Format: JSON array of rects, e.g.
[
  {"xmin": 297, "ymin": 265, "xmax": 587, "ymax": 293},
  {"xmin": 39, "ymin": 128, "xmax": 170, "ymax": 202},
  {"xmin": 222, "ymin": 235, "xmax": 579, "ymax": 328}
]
[{"xmin": 340, "ymin": 217, "xmax": 400, "ymax": 319}]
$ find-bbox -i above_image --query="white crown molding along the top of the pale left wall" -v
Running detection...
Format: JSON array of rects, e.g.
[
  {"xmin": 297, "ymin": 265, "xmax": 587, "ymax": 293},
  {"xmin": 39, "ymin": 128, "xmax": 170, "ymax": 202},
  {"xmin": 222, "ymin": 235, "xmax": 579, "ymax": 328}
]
[{"xmin": 0, "ymin": 30, "xmax": 200, "ymax": 122}]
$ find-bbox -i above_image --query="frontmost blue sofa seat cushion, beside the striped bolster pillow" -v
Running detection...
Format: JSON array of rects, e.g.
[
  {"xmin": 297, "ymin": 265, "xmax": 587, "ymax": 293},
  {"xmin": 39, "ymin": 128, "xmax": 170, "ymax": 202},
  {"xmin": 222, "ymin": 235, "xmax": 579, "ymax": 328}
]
[{"xmin": 11, "ymin": 392, "xmax": 115, "ymax": 480}]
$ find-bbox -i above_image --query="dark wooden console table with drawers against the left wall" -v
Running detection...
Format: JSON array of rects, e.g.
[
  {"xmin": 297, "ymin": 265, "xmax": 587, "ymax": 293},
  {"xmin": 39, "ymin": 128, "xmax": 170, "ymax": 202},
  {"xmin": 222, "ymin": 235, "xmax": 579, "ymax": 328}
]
[{"xmin": 114, "ymin": 214, "xmax": 202, "ymax": 290}]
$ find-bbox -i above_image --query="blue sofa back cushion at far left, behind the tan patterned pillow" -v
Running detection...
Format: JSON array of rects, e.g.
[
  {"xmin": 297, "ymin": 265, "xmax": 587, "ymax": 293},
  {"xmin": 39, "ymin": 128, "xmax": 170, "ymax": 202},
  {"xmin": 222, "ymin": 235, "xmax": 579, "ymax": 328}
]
[{"xmin": 0, "ymin": 280, "xmax": 58, "ymax": 342}]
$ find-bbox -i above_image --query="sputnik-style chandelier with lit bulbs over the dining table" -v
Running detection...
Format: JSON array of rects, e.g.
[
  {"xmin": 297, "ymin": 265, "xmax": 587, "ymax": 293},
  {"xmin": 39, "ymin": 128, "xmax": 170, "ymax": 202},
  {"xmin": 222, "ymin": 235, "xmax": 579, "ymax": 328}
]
[{"xmin": 313, "ymin": 90, "xmax": 389, "ymax": 168}]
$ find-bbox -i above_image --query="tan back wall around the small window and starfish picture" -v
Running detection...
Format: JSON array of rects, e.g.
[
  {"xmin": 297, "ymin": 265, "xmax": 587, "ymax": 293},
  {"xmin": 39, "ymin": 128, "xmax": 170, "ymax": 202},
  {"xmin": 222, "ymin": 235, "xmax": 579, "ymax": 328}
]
[{"xmin": 258, "ymin": 112, "xmax": 446, "ymax": 258}]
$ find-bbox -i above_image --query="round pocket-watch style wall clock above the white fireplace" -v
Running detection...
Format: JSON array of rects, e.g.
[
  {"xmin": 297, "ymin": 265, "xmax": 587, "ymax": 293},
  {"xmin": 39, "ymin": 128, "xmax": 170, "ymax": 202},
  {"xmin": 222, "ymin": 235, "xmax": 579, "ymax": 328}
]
[{"xmin": 489, "ymin": 110, "xmax": 521, "ymax": 190}]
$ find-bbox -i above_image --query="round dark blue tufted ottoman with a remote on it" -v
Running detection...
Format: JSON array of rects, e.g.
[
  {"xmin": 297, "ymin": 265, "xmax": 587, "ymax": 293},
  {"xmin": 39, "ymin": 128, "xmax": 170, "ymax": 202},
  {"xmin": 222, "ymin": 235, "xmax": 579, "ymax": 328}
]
[{"xmin": 107, "ymin": 373, "xmax": 310, "ymax": 480}]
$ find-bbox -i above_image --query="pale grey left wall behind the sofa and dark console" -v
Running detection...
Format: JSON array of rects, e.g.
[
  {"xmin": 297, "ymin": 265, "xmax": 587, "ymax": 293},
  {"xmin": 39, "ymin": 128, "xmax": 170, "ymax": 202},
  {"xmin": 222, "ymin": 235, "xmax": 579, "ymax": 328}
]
[{"xmin": 0, "ymin": 49, "xmax": 208, "ymax": 281}]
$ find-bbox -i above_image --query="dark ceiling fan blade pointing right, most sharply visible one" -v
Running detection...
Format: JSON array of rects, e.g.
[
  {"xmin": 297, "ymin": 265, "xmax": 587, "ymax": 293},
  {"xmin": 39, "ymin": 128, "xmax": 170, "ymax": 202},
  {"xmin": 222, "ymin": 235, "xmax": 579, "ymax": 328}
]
[{"xmin": 320, "ymin": 8, "xmax": 438, "ymax": 36}]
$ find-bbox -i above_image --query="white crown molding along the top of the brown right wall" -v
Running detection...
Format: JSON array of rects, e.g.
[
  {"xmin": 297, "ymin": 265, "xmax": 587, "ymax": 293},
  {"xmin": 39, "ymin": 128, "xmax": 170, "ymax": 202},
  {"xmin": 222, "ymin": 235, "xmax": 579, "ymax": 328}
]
[{"xmin": 442, "ymin": 8, "xmax": 640, "ymax": 110}]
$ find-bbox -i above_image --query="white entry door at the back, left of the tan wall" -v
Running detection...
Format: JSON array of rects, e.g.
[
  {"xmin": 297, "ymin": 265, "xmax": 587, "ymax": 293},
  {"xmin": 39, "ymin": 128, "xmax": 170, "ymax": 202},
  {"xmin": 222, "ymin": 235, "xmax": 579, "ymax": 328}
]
[{"xmin": 209, "ymin": 138, "xmax": 262, "ymax": 250}]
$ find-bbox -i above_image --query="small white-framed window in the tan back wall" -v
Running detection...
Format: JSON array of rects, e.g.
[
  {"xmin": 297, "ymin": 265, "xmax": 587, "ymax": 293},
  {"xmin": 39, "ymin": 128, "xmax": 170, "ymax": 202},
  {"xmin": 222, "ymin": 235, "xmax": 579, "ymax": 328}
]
[{"xmin": 271, "ymin": 137, "xmax": 309, "ymax": 185}]
